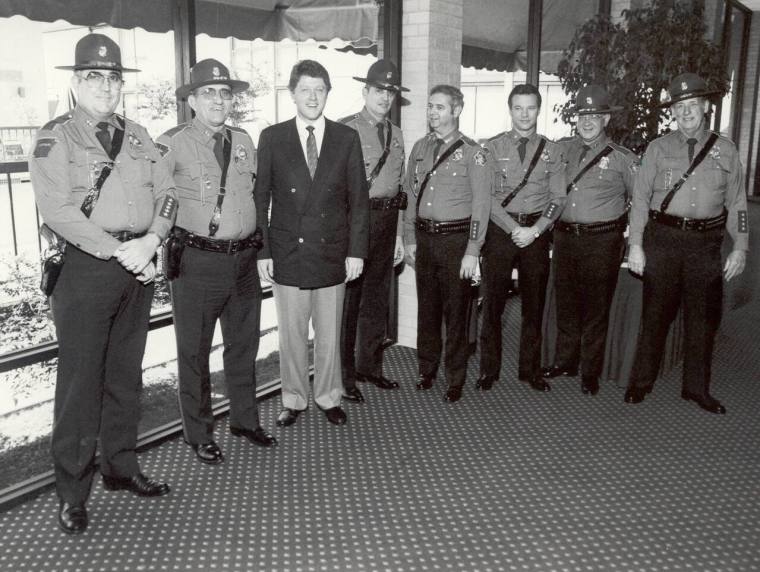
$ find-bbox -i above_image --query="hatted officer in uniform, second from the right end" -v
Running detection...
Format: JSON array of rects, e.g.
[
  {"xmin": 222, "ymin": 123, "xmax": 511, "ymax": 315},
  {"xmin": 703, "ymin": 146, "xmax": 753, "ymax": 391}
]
[{"xmin": 543, "ymin": 85, "xmax": 638, "ymax": 395}]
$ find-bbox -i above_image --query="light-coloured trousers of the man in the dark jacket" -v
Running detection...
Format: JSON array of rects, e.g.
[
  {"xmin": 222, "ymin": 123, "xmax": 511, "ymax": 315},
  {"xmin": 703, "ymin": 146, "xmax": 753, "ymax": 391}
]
[{"xmin": 273, "ymin": 283, "xmax": 346, "ymax": 410}]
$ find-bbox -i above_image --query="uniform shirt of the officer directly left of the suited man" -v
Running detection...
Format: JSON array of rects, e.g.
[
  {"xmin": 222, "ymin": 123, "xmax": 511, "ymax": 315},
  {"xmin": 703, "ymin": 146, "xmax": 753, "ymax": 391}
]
[{"xmin": 158, "ymin": 117, "xmax": 256, "ymax": 240}]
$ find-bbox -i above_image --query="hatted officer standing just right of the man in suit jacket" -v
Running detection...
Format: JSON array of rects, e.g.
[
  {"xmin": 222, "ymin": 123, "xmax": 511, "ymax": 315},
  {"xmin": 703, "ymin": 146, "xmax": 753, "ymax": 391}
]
[{"xmin": 341, "ymin": 60, "xmax": 409, "ymax": 402}]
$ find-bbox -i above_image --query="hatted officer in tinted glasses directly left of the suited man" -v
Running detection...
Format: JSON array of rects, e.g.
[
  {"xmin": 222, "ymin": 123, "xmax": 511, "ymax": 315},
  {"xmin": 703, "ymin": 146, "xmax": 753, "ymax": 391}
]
[{"xmin": 158, "ymin": 59, "xmax": 276, "ymax": 465}]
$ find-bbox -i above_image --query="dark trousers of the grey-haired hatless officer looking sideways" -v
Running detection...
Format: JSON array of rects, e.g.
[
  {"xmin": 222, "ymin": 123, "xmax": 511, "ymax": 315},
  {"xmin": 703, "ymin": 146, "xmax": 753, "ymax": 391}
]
[{"xmin": 414, "ymin": 231, "xmax": 472, "ymax": 388}]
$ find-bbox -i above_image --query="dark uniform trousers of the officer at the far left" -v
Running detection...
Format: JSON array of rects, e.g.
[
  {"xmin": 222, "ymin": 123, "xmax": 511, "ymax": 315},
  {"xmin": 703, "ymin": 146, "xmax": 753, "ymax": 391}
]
[{"xmin": 51, "ymin": 244, "xmax": 153, "ymax": 504}]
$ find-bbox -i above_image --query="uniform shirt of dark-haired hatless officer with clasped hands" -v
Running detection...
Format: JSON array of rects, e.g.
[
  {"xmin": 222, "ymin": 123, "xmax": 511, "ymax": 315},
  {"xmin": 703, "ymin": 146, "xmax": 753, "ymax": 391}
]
[{"xmin": 485, "ymin": 129, "xmax": 566, "ymax": 233}]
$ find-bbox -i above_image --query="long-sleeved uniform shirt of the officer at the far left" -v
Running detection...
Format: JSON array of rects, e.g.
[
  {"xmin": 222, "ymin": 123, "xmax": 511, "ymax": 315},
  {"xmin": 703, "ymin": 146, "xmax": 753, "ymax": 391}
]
[{"xmin": 29, "ymin": 107, "xmax": 176, "ymax": 260}]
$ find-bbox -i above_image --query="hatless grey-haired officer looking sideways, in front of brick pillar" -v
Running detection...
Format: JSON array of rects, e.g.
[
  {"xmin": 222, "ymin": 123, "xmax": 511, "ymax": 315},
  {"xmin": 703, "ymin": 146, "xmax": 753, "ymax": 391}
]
[{"xmin": 404, "ymin": 85, "xmax": 491, "ymax": 402}]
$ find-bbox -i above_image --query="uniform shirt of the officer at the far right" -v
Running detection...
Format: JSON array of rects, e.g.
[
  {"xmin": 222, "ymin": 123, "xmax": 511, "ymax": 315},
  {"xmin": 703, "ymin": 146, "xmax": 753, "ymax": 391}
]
[{"xmin": 630, "ymin": 130, "xmax": 749, "ymax": 250}]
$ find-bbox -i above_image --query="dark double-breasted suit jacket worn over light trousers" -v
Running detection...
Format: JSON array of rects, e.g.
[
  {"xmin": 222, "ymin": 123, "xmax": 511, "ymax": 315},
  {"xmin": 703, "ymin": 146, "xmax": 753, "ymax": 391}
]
[{"xmin": 253, "ymin": 118, "xmax": 369, "ymax": 288}]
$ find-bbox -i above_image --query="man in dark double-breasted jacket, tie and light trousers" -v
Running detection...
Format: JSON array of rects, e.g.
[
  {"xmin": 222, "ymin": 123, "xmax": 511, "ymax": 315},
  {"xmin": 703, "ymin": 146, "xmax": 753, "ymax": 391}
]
[{"xmin": 254, "ymin": 60, "xmax": 369, "ymax": 427}]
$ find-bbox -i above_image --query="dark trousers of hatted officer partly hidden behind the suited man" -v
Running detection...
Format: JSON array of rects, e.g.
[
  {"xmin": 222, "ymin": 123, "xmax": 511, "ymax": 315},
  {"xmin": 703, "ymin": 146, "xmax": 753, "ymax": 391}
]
[{"xmin": 340, "ymin": 210, "xmax": 398, "ymax": 388}]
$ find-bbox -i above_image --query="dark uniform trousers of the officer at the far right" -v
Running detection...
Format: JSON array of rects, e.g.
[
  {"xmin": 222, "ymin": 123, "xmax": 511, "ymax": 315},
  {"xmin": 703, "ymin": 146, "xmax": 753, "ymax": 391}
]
[{"xmin": 630, "ymin": 221, "xmax": 723, "ymax": 397}]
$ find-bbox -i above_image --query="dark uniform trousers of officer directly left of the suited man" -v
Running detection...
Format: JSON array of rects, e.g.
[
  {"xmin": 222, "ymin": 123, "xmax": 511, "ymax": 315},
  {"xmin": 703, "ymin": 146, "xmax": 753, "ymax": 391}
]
[{"xmin": 171, "ymin": 247, "xmax": 261, "ymax": 444}]
